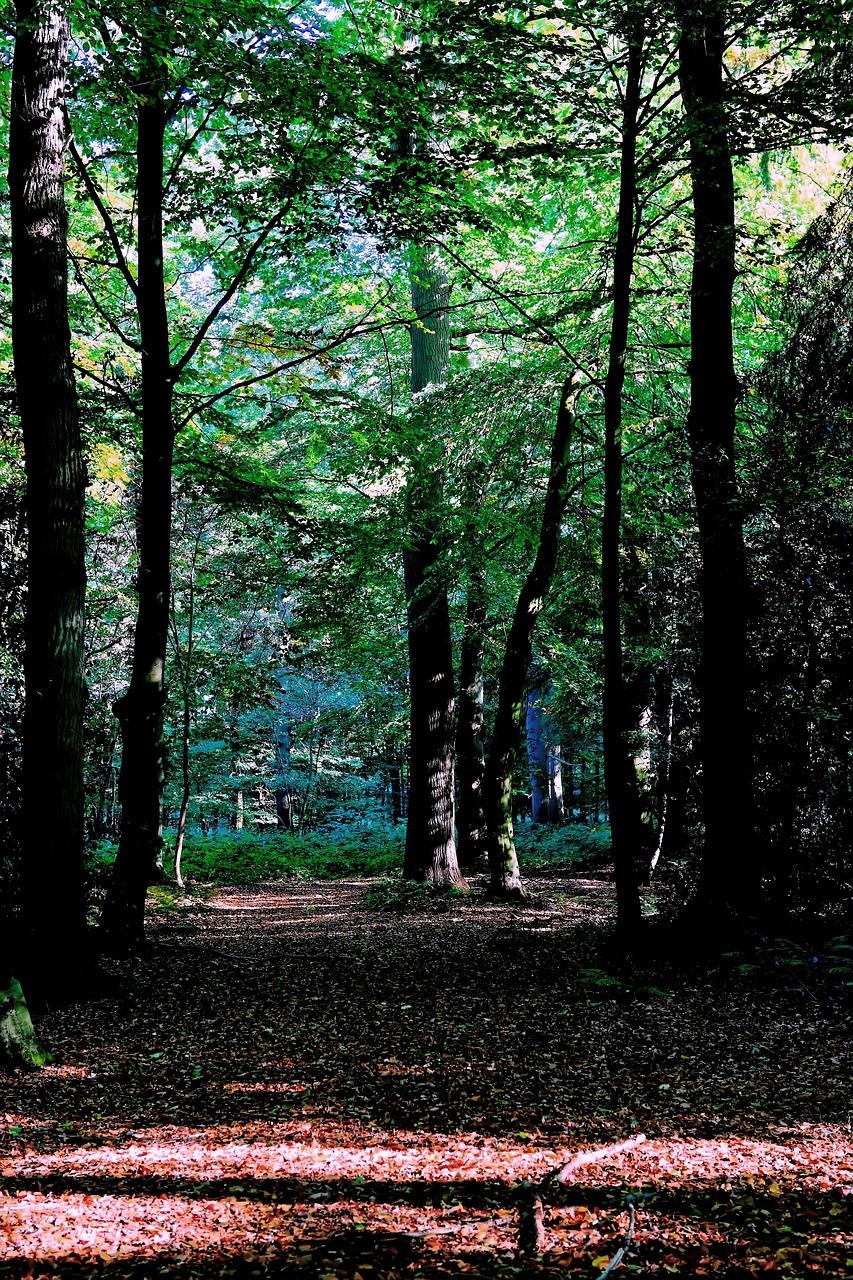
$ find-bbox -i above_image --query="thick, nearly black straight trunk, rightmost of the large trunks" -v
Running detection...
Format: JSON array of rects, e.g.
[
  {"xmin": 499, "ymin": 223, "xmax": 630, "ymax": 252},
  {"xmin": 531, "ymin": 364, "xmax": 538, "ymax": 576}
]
[{"xmin": 679, "ymin": 0, "xmax": 758, "ymax": 932}]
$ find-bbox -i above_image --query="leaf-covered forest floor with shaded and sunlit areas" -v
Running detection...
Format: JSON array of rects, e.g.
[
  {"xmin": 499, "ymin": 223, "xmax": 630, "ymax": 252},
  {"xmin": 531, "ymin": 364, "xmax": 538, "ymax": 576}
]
[{"xmin": 0, "ymin": 872, "xmax": 853, "ymax": 1280}]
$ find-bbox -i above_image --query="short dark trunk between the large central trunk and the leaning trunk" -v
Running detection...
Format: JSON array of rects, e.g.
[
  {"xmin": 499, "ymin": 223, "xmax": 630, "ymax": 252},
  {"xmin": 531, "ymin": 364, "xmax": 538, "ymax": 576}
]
[{"xmin": 456, "ymin": 567, "xmax": 487, "ymax": 870}]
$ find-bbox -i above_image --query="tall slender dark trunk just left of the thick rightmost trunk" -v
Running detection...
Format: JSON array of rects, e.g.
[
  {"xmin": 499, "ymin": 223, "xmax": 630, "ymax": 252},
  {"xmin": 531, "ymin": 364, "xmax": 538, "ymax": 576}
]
[{"xmin": 601, "ymin": 18, "xmax": 643, "ymax": 937}]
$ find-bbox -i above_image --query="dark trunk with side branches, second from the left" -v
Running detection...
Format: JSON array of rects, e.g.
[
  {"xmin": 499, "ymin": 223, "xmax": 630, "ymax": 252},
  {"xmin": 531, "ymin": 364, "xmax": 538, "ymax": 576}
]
[{"xmin": 101, "ymin": 49, "xmax": 174, "ymax": 951}]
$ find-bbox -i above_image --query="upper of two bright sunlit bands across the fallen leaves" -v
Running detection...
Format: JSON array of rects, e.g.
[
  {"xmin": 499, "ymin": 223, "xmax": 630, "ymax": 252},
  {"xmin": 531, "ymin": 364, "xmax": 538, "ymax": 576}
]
[{"xmin": 0, "ymin": 1131, "xmax": 853, "ymax": 1194}]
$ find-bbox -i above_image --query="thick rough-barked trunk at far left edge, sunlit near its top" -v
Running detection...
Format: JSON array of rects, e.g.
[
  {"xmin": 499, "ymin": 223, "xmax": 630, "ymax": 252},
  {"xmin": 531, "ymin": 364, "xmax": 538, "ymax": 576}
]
[{"xmin": 9, "ymin": 0, "xmax": 86, "ymax": 998}]
